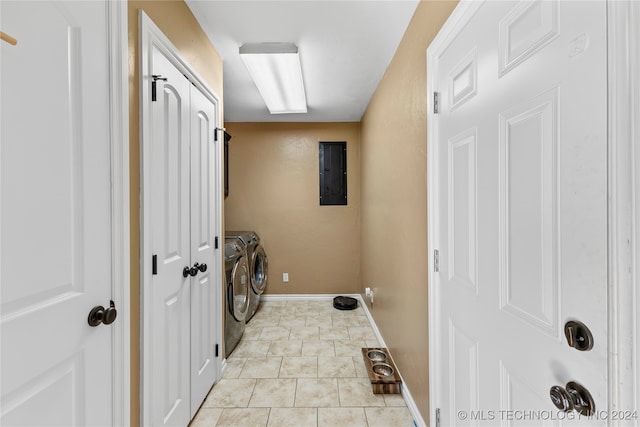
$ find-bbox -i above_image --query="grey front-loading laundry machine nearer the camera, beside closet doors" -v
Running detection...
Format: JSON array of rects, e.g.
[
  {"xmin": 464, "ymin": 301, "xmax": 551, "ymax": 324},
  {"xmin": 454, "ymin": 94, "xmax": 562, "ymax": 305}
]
[{"xmin": 224, "ymin": 239, "xmax": 251, "ymax": 357}]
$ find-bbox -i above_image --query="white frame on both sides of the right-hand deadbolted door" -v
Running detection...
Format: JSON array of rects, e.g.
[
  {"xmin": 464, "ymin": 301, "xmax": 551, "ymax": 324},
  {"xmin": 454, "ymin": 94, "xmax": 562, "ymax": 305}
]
[{"xmin": 427, "ymin": 0, "xmax": 640, "ymax": 426}]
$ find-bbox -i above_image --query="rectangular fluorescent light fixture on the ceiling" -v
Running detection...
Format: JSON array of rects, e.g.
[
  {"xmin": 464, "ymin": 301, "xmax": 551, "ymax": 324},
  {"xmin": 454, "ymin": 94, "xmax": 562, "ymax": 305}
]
[{"xmin": 240, "ymin": 43, "xmax": 307, "ymax": 114}]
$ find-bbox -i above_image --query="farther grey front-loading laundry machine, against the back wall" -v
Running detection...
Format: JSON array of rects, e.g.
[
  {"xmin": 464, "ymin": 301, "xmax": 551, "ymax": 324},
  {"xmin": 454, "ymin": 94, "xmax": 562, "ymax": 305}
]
[{"xmin": 225, "ymin": 231, "xmax": 269, "ymax": 322}]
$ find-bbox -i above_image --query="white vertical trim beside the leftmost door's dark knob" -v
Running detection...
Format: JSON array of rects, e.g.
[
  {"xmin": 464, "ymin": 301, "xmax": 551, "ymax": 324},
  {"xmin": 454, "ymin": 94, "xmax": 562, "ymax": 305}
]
[{"xmin": 107, "ymin": 0, "xmax": 131, "ymax": 426}]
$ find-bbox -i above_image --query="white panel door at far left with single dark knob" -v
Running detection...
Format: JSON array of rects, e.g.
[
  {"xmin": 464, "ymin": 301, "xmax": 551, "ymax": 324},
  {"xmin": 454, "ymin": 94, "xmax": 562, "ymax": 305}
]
[{"xmin": 0, "ymin": 1, "xmax": 117, "ymax": 426}]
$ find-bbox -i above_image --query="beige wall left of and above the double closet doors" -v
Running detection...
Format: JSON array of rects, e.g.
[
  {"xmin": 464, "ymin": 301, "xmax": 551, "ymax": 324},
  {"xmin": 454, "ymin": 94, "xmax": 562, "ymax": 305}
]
[{"xmin": 128, "ymin": 0, "xmax": 222, "ymax": 426}]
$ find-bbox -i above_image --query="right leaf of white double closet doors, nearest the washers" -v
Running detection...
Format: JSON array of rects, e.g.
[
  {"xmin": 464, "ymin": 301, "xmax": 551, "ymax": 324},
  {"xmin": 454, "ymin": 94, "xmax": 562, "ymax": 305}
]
[{"xmin": 190, "ymin": 85, "xmax": 221, "ymax": 416}]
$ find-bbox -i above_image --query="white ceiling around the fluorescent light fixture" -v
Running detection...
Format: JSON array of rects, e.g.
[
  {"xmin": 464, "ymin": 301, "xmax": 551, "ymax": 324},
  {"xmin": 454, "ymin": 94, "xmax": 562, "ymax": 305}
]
[{"xmin": 186, "ymin": 0, "xmax": 418, "ymax": 122}]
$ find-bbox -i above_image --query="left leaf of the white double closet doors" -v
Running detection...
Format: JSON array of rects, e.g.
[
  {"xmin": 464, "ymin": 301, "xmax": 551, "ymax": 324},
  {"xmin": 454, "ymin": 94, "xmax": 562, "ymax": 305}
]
[{"xmin": 149, "ymin": 49, "xmax": 192, "ymax": 426}]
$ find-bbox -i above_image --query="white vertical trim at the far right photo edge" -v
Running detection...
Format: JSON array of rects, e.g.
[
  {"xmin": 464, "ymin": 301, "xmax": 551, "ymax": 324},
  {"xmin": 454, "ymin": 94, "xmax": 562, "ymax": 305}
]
[{"xmin": 607, "ymin": 0, "xmax": 640, "ymax": 426}]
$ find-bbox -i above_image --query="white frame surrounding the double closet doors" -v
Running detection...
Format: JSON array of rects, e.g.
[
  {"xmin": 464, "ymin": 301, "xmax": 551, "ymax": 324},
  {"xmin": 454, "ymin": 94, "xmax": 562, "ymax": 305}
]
[{"xmin": 139, "ymin": 10, "xmax": 224, "ymax": 425}]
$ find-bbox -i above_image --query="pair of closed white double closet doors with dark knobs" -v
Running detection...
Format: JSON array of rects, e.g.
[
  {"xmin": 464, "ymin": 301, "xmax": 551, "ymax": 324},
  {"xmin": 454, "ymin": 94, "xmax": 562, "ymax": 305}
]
[{"xmin": 145, "ymin": 48, "xmax": 220, "ymax": 425}]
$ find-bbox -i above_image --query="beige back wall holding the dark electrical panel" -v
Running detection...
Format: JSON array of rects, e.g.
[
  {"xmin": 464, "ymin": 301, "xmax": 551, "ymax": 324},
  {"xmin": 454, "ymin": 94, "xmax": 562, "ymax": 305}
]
[{"xmin": 225, "ymin": 123, "xmax": 360, "ymax": 294}]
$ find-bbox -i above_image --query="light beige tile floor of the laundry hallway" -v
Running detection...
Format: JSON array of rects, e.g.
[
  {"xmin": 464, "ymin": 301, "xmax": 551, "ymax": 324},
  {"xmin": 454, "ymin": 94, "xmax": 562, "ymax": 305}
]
[{"xmin": 191, "ymin": 300, "xmax": 414, "ymax": 427}]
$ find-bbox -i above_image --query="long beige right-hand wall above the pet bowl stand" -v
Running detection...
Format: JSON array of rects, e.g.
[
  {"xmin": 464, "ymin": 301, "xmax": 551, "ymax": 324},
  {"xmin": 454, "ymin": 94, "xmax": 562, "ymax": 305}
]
[{"xmin": 361, "ymin": 1, "xmax": 456, "ymax": 420}]
